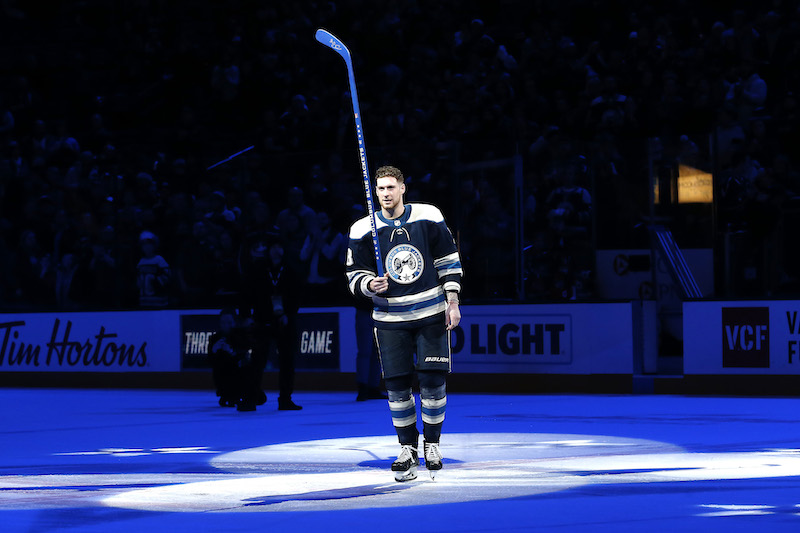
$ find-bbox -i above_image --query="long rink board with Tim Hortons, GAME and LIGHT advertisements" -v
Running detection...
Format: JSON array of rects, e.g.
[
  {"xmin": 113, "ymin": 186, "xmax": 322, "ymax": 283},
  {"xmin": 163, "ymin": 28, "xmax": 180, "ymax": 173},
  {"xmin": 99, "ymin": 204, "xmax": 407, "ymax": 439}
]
[{"xmin": 0, "ymin": 303, "xmax": 641, "ymax": 375}]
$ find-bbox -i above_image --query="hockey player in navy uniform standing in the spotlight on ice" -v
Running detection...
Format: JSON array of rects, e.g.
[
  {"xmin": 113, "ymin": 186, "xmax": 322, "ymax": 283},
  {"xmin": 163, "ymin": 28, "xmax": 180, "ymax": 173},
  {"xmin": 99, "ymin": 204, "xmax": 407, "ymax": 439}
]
[{"xmin": 346, "ymin": 166, "xmax": 462, "ymax": 481}]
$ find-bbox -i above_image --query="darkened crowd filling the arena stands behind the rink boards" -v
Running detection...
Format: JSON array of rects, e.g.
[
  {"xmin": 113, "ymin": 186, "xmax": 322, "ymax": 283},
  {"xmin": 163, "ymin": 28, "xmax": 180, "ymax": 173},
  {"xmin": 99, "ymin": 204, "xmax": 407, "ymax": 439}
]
[{"xmin": 0, "ymin": 0, "xmax": 800, "ymax": 310}]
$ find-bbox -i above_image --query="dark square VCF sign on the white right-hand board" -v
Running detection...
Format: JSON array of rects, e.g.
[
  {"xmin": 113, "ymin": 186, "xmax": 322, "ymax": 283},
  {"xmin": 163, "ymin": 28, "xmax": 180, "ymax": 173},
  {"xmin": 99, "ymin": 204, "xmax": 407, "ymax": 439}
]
[{"xmin": 722, "ymin": 307, "xmax": 769, "ymax": 368}]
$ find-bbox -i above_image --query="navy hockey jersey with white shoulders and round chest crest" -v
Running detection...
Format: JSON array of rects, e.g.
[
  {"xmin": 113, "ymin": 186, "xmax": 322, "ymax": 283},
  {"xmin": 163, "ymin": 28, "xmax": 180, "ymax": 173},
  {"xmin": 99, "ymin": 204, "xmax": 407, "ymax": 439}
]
[{"xmin": 346, "ymin": 203, "xmax": 463, "ymax": 329}]
